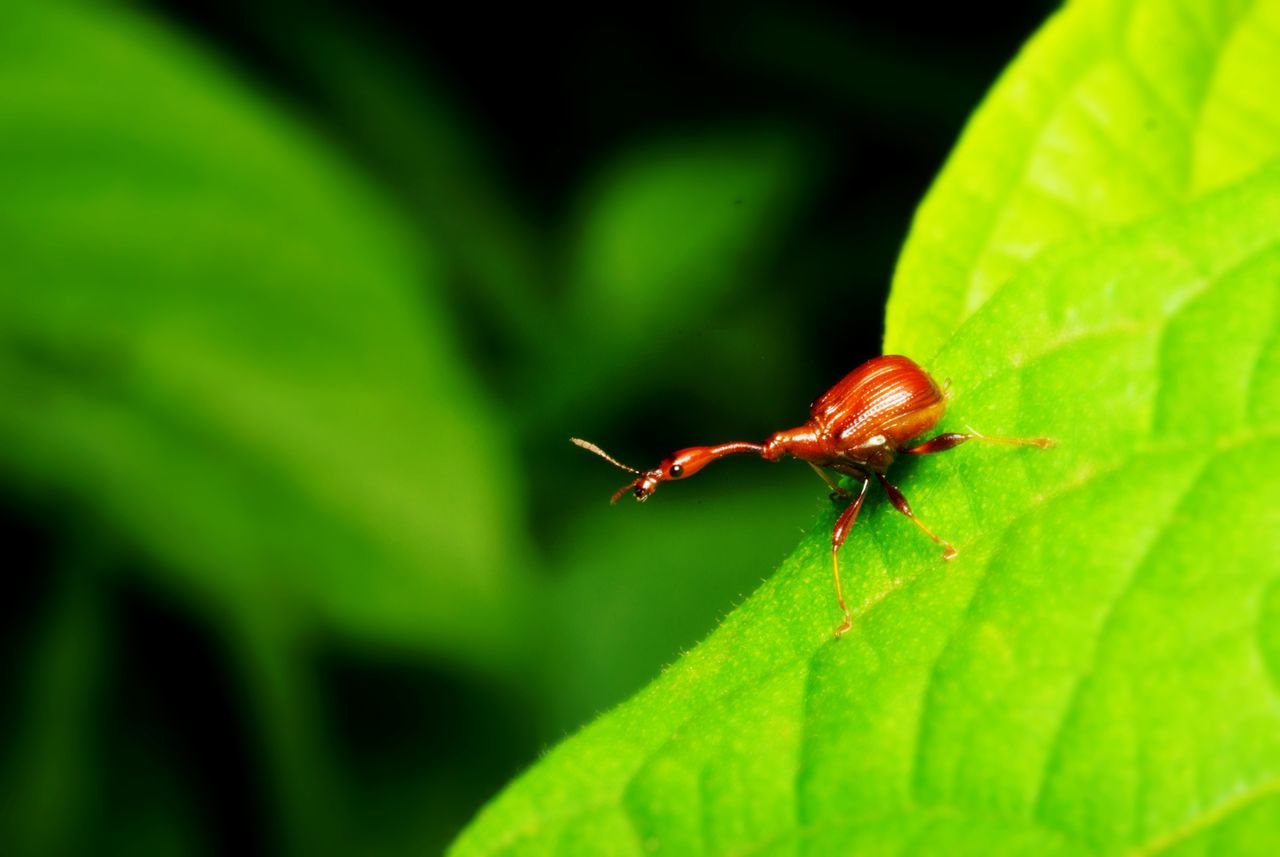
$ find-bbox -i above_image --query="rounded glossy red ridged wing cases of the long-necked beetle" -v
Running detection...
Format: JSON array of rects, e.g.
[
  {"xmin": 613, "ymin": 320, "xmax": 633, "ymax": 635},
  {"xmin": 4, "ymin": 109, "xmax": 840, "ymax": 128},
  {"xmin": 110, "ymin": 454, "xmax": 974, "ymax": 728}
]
[{"xmin": 809, "ymin": 354, "xmax": 946, "ymax": 449}]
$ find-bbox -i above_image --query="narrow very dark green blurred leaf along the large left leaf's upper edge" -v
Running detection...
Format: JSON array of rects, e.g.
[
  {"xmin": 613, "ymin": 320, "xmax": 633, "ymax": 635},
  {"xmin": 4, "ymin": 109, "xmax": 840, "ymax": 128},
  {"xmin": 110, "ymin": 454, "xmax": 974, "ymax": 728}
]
[{"xmin": 235, "ymin": 4, "xmax": 548, "ymax": 358}]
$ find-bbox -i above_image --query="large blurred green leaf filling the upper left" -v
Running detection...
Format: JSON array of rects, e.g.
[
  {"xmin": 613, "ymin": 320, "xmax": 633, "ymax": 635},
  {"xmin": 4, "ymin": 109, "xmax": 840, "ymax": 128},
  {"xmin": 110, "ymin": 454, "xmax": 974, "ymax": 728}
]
[{"xmin": 0, "ymin": 4, "xmax": 521, "ymax": 663}]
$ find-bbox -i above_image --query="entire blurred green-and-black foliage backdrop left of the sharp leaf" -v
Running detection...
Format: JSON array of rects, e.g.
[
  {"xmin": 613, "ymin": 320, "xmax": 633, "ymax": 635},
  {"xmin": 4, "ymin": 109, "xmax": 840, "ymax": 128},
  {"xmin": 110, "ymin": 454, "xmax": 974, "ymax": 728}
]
[{"xmin": 0, "ymin": 0, "xmax": 1059, "ymax": 854}]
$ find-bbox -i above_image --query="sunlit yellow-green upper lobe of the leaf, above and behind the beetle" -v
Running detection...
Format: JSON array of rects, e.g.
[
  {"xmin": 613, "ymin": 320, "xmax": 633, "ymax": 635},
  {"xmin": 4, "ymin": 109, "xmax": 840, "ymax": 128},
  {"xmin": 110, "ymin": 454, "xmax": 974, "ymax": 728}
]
[{"xmin": 886, "ymin": 0, "xmax": 1280, "ymax": 357}]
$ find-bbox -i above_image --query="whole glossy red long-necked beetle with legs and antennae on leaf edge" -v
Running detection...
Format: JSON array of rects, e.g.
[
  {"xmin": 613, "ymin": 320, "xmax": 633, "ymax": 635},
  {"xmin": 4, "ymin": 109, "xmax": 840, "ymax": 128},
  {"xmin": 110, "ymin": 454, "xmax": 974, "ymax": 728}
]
[{"xmin": 571, "ymin": 354, "xmax": 1053, "ymax": 638}]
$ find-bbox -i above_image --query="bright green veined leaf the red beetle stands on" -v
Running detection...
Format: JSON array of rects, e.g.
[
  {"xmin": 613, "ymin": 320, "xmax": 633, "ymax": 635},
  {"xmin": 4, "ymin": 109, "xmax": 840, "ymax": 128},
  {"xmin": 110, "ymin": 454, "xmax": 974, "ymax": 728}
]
[{"xmin": 454, "ymin": 0, "xmax": 1280, "ymax": 854}]
